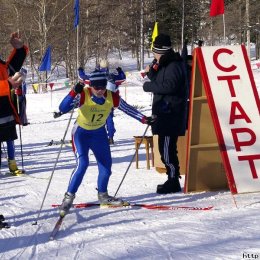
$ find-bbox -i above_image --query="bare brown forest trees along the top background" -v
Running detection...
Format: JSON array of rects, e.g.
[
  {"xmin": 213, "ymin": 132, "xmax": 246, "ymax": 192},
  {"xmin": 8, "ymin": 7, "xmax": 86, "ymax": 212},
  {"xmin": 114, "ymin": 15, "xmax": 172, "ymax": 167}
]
[{"xmin": 0, "ymin": 0, "xmax": 260, "ymax": 80}]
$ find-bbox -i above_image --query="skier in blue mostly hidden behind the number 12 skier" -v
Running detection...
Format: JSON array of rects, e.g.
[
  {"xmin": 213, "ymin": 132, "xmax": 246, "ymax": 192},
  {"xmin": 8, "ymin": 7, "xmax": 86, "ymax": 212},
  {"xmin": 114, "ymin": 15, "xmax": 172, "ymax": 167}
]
[{"xmin": 78, "ymin": 60, "xmax": 126, "ymax": 145}]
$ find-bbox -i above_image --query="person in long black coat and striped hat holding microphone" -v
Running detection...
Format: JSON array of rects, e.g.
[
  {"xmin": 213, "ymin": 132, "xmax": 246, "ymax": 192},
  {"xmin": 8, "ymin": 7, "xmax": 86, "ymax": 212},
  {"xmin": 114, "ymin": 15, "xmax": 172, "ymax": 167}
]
[{"xmin": 143, "ymin": 34, "xmax": 188, "ymax": 194}]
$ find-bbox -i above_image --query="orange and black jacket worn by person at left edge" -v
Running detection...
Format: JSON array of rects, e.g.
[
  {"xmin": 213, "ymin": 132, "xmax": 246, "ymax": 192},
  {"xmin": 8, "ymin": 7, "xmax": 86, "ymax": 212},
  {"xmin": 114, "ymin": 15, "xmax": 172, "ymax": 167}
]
[{"xmin": 0, "ymin": 46, "xmax": 28, "ymax": 125}]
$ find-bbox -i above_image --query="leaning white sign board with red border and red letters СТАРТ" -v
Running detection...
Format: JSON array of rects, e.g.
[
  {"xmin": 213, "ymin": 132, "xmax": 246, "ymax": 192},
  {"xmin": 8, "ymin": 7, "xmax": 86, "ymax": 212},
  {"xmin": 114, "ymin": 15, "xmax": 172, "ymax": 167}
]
[{"xmin": 191, "ymin": 46, "xmax": 260, "ymax": 193}]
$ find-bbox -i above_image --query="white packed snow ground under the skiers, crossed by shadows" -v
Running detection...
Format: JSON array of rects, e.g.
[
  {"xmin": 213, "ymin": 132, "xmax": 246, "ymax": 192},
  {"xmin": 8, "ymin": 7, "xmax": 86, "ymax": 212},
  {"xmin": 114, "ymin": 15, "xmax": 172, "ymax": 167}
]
[{"xmin": 0, "ymin": 62, "xmax": 260, "ymax": 260}]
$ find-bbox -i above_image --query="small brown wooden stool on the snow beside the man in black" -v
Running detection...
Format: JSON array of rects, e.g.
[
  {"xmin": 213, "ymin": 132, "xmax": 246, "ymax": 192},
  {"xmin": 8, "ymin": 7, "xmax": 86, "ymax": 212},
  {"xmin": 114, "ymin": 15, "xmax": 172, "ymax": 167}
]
[{"xmin": 134, "ymin": 136, "xmax": 154, "ymax": 170}]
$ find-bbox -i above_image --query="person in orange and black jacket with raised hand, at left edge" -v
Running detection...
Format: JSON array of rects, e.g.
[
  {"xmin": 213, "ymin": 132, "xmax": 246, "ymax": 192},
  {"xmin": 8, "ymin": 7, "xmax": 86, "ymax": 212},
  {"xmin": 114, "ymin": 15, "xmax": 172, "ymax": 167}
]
[{"xmin": 0, "ymin": 32, "xmax": 28, "ymax": 175}]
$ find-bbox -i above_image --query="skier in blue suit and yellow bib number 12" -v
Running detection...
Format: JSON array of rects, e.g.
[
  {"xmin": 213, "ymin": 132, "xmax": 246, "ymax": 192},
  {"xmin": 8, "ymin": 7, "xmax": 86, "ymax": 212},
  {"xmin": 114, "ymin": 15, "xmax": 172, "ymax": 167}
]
[{"xmin": 55, "ymin": 69, "xmax": 152, "ymax": 217}]
